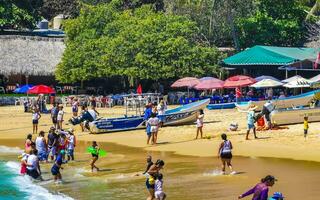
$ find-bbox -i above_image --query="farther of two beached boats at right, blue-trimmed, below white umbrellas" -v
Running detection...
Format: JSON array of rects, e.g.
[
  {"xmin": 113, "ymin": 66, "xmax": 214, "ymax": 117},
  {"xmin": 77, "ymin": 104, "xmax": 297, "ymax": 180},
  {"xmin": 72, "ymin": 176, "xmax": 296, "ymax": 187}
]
[{"xmin": 235, "ymin": 90, "xmax": 320, "ymax": 111}]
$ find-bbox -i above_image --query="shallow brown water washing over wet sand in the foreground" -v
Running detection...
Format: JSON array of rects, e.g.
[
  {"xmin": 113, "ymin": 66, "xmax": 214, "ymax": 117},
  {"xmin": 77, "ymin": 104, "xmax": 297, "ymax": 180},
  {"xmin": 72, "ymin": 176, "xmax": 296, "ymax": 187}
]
[{"xmin": 0, "ymin": 140, "xmax": 320, "ymax": 200}]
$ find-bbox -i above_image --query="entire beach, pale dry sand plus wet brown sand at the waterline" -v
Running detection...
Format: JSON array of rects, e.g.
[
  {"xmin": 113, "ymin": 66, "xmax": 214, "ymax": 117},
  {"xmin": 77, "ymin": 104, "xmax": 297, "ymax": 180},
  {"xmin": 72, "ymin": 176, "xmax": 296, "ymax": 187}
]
[{"xmin": 0, "ymin": 106, "xmax": 320, "ymax": 200}]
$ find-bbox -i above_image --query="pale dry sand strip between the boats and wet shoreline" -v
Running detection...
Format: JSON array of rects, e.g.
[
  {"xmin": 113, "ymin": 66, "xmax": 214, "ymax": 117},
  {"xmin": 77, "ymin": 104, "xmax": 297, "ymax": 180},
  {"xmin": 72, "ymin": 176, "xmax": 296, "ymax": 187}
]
[{"xmin": 0, "ymin": 106, "xmax": 320, "ymax": 162}]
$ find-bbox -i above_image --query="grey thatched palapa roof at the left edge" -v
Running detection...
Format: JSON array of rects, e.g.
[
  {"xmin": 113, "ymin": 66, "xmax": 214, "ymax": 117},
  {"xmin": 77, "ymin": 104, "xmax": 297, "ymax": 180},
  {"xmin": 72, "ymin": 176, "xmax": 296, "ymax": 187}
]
[{"xmin": 0, "ymin": 35, "xmax": 65, "ymax": 75}]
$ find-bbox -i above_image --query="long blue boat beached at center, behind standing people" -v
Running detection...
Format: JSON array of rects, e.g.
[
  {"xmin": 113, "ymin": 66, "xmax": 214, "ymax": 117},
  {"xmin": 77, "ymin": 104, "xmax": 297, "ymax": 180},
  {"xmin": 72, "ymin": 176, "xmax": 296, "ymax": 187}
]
[{"xmin": 89, "ymin": 99, "xmax": 210, "ymax": 133}]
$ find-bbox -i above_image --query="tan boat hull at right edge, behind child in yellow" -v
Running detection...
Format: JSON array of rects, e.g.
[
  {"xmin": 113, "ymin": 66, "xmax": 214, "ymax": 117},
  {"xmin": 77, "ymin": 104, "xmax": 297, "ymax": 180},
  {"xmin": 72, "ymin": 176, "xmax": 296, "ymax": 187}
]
[{"xmin": 270, "ymin": 108, "xmax": 320, "ymax": 125}]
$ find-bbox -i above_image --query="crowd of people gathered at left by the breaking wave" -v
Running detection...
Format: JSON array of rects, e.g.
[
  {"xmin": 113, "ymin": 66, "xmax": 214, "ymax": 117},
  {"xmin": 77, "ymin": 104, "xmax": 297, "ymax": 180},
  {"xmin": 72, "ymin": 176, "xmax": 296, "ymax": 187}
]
[{"xmin": 20, "ymin": 127, "xmax": 76, "ymax": 182}]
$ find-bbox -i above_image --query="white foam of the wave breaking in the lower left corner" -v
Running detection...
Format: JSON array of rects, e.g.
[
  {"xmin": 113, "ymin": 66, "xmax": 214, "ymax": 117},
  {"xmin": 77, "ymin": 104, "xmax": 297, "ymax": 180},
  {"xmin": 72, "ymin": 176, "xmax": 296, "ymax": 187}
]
[{"xmin": 6, "ymin": 161, "xmax": 72, "ymax": 200}]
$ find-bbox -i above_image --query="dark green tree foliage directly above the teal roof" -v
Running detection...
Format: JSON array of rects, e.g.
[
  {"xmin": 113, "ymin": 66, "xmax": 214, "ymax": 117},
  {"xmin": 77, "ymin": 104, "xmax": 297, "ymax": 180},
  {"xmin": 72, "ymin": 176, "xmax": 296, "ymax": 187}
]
[{"xmin": 237, "ymin": 0, "xmax": 306, "ymax": 48}]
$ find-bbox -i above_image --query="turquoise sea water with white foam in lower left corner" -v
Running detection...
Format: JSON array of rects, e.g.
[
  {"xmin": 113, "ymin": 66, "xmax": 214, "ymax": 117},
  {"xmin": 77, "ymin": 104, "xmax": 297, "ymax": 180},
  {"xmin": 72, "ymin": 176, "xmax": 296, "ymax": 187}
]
[{"xmin": 0, "ymin": 146, "xmax": 72, "ymax": 200}]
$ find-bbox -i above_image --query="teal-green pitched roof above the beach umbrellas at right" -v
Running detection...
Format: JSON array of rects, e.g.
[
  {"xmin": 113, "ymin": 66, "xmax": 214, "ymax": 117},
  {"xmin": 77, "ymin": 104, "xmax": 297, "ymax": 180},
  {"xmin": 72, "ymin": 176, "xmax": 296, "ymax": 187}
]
[{"xmin": 223, "ymin": 45, "xmax": 320, "ymax": 66}]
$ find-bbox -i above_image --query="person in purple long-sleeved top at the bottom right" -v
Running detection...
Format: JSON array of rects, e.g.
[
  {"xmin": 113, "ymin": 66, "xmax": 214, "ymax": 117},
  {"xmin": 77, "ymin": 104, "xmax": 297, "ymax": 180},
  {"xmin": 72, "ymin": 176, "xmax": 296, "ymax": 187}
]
[{"xmin": 238, "ymin": 175, "xmax": 277, "ymax": 200}]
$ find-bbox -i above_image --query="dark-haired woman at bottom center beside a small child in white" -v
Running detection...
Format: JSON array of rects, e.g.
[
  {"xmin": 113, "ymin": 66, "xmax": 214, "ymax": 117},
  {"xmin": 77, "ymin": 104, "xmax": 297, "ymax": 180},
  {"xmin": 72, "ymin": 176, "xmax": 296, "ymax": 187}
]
[{"xmin": 146, "ymin": 160, "xmax": 164, "ymax": 200}]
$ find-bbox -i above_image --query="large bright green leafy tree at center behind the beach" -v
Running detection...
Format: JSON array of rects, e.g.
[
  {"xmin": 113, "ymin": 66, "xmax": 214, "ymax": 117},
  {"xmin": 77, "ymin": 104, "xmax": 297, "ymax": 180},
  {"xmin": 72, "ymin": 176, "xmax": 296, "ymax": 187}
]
[{"xmin": 56, "ymin": 3, "xmax": 222, "ymax": 82}]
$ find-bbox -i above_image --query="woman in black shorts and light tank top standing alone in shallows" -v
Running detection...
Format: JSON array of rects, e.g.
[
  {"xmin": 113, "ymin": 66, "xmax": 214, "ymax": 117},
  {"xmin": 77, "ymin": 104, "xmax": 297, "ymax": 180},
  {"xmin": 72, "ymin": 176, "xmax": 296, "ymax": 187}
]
[{"xmin": 218, "ymin": 133, "xmax": 236, "ymax": 174}]
